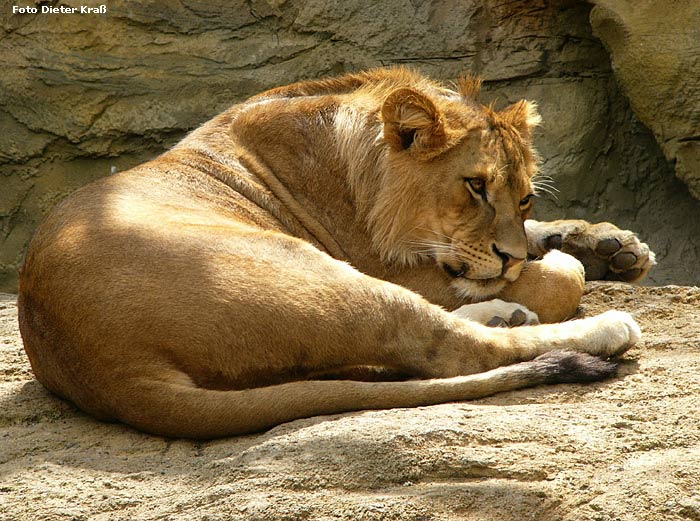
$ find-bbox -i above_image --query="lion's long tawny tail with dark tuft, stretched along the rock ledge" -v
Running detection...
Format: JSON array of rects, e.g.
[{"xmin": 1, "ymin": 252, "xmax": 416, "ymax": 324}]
[{"xmin": 106, "ymin": 351, "xmax": 617, "ymax": 438}]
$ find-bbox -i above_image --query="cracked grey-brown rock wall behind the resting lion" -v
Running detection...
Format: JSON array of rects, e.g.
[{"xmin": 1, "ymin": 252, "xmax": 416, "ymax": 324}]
[{"xmin": 0, "ymin": 0, "xmax": 700, "ymax": 291}]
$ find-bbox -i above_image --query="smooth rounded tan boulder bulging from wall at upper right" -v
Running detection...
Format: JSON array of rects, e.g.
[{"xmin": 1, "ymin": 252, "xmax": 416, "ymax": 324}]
[{"xmin": 591, "ymin": 0, "xmax": 700, "ymax": 199}]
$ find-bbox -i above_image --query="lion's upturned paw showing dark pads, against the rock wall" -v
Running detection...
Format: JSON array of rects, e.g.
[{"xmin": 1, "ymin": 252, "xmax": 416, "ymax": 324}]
[{"xmin": 544, "ymin": 223, "xmax": 656, "ymax": 282}]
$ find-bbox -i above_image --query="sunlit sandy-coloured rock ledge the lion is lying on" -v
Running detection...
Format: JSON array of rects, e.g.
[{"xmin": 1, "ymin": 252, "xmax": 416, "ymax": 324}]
[{"xmin": 0, "ymin": 283, "xmax": 700, "ymax": 521}]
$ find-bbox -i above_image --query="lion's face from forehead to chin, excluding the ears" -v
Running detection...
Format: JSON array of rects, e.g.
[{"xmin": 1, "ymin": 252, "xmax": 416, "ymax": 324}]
[{"xmin": 413, "ymin": 129, "xmax": 534, "ymax": 297}]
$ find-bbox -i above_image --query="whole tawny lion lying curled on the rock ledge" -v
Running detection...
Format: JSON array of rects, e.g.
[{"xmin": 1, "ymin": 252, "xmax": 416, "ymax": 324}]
[{"xmin": 19, "ymin": 69, "xmax": 654, "ymax": 438}]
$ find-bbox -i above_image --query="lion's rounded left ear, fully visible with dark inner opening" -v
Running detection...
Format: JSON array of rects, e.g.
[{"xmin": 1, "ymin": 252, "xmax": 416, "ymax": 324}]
[{"xmin": 382, "ymin": 88, "xmax": 447, "ymax": 152}]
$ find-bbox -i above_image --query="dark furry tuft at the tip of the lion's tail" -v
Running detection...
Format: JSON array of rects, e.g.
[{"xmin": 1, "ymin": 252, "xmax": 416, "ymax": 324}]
[{"xmin": 530, "ymin": 351, "xmax": 618, "ymax": 384}]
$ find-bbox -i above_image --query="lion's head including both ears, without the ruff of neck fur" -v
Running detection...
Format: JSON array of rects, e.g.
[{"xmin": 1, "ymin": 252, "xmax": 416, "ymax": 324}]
[{"xmin": 383, "ymin": 83, "xmax": 538, "ymax": 298}]
